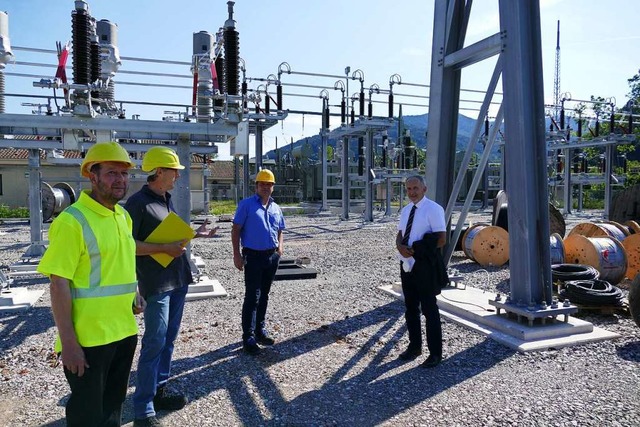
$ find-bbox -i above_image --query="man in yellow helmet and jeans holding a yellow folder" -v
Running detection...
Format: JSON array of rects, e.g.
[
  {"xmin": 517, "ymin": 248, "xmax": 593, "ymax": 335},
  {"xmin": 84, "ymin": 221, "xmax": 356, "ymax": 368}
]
[{"xmin": 125, "ymin": 146, "xmax": 216, "ymax": 427}]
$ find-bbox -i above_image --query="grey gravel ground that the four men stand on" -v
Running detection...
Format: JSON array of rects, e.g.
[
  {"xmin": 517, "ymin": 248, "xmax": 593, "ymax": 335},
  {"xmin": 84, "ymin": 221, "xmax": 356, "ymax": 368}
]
[{"xmin": 0, "ymin": 209, "xmax": 640, "ymax": 426}]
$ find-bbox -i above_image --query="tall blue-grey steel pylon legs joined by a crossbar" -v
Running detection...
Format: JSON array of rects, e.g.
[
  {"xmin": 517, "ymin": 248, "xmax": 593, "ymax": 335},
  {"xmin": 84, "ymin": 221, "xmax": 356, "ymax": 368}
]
[{"xmin": 426, "ymin": 0, "xmax": 577, "ymax": 318}]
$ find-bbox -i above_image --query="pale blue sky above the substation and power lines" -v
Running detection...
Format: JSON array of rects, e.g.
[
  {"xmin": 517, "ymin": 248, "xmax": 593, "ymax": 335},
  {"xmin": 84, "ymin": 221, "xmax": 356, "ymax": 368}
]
[{"xmin": 0, "ymin": 0, "xmax": 640, "ymax": 157}]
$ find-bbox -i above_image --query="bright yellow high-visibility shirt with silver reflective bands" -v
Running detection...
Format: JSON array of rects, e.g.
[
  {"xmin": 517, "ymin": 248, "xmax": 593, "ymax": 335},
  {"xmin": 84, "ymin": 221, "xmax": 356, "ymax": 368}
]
[{"xmin": 38, "ymin": 190, "xmax": 138, "ymax": 351}]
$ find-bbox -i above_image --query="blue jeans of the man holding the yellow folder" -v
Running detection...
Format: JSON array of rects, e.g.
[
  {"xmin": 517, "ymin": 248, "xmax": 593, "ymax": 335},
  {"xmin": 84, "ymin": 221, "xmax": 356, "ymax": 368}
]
[{"xmin": 133, "ymin": 286, "xmax": 189, "ymax": 419}]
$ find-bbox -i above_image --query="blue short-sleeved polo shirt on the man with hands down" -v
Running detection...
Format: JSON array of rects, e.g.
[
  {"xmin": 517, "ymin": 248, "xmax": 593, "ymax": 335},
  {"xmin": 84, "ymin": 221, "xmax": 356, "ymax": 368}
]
[{"xmin": 233, "ymin": 194, "xmax": 285, "ymax": 251}]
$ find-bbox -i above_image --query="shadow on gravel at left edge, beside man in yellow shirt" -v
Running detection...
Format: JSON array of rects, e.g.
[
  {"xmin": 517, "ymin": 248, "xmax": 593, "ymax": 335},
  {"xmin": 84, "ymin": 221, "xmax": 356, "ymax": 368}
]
[{"xmin": 0, "ymin": 307, "xmax": 54, "ymax": 353}]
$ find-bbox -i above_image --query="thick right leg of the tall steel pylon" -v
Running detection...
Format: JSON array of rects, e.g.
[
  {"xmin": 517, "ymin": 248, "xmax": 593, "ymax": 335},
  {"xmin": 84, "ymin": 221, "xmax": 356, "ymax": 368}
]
[{"xmin": 499, "ymin": 0, "xmax": 553, "ymax": 306}]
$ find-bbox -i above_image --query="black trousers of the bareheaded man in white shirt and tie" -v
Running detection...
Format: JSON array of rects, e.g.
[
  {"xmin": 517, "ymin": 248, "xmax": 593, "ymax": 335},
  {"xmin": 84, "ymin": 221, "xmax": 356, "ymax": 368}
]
[{"xmin": 400, "ymin": 268, "xmax": 442, "ymax": 357}]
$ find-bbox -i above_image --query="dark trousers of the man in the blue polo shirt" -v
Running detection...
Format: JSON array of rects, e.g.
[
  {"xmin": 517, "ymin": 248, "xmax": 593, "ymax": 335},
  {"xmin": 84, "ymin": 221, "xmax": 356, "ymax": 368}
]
[{"xmin": 242, "ymin": 252, "xmax": 280, "ymax": 340}]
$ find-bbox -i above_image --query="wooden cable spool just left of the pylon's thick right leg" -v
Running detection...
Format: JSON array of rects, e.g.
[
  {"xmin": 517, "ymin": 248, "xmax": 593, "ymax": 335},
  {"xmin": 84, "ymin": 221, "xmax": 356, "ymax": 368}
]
[{"xmin": 462, "ymin": 224, "xmax": 509, "ymax": 267}]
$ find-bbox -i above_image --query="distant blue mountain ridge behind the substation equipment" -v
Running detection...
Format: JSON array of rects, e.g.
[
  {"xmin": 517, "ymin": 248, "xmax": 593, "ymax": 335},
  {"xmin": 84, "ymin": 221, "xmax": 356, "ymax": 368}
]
[{"xmin": 265, "ymin": 114, "xmax": 482, "ymax": 159}]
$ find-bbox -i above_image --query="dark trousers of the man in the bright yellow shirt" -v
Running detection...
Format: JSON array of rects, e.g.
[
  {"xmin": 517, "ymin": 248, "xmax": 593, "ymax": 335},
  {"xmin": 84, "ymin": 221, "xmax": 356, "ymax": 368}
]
[{"xmin": 64, "ymin": 335, "xmax": 138, "ymax": 427}]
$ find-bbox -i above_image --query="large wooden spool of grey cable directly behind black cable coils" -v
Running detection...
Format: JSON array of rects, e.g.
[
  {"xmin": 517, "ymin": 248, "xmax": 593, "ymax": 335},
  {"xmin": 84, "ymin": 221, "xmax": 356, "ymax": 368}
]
[{"xmin": 564, "ymin": 233, "xmax": 627, "ymax": 285}]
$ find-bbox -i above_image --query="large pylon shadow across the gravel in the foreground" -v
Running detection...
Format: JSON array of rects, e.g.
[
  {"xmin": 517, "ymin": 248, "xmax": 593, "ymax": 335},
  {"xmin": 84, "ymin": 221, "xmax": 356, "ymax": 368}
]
[{"xmin": 164, "ymin": 302, "xmax": 515, "ymax": 425}]
